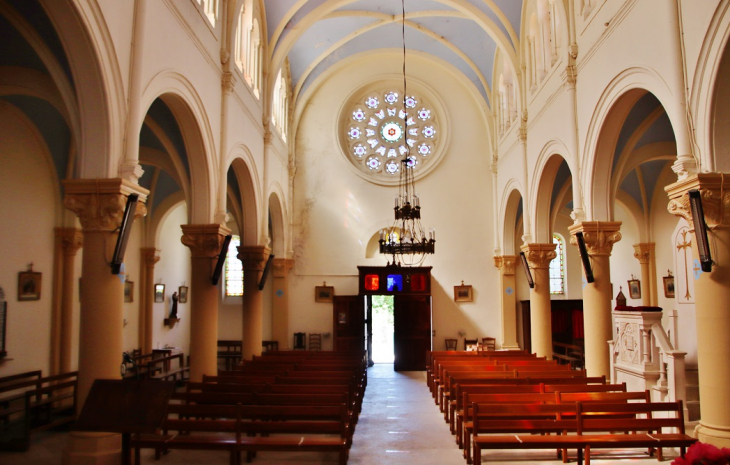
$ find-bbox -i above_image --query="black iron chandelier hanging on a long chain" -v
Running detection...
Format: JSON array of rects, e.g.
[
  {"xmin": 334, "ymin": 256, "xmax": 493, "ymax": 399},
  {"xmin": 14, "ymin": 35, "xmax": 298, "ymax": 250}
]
[{"xmin": 379, "ymin": 0, "xmax": 436, "ymax": 266}]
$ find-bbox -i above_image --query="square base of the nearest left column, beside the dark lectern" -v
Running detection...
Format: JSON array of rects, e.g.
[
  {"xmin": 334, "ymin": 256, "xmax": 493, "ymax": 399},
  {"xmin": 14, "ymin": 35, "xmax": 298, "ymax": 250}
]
[{"xmin": 61, "ymin": 432, "xmax": 122, "ymax": 465}]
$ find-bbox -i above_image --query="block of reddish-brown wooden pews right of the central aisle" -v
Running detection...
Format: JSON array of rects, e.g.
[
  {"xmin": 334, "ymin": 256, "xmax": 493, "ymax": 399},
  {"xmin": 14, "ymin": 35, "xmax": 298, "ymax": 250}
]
[{"xmin": 427, "ymin": 351, "xmax": 696, "ymax": 464}]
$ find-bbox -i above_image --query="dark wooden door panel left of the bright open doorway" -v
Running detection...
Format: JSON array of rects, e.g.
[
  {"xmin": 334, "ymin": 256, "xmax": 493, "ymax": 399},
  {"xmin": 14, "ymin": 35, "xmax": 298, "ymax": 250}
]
[{"xmin": 332, "ymin": 295, "xmax": 365, "ymax": 352}]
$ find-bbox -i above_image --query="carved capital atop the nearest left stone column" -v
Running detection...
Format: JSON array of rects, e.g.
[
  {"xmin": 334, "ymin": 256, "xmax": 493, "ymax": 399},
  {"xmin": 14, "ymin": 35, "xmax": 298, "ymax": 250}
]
[{"xmin": 63, "ymin": 178, "xmax": 149, "ymax": 232}]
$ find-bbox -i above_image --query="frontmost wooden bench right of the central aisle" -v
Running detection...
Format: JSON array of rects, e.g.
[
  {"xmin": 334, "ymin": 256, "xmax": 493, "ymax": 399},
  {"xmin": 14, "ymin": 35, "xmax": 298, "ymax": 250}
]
[{"xmin": 472, "ymin": 401, "xmax": 697, "ymax": 465}]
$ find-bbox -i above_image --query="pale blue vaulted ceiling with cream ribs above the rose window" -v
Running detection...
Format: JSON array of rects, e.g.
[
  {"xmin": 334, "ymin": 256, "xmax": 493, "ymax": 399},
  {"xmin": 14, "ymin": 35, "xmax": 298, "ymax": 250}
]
[{"xmin": 263, "ymin": 0, "xmax": 524, "ymax": 107}]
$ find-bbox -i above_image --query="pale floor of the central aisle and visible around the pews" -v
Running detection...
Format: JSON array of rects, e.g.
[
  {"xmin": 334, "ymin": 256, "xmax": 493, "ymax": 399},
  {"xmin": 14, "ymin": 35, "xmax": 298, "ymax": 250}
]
[{"xmin": 0, "ymin": 364, "xmax": 671, "ymax": 465}]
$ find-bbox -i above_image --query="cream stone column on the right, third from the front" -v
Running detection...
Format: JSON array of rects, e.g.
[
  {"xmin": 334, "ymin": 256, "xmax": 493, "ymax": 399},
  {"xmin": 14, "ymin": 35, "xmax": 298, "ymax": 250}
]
[{"xmin": 521, "ymin": 243, "xmax": 557, "ymax": 360}]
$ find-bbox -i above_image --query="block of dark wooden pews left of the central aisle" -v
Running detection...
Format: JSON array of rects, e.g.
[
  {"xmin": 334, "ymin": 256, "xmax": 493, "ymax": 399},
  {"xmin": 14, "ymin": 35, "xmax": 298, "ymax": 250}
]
[{"xmin": 132, "ymin": 351, "xmax": 367, "ymax": 465}]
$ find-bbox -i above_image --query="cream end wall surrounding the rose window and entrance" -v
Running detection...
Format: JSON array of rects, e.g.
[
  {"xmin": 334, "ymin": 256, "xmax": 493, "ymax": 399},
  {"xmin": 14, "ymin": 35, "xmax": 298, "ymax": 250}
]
[{"xmin": 290, "ymin": 54, "xmax": 499, "ymax": 350}]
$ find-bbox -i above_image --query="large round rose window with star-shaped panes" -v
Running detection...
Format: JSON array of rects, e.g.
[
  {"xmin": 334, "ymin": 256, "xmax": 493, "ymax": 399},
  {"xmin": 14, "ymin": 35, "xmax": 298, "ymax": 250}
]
[{"xmin": 342, "ymin": 89, "xmax": 439, "ymax": 180}]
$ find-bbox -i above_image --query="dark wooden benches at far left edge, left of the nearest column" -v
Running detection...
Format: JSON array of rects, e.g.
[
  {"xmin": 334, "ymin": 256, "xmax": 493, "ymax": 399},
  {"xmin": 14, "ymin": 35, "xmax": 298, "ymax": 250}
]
[{"xmin": 0, "ymin": 372, "xmax": 78, "ymax": 451}]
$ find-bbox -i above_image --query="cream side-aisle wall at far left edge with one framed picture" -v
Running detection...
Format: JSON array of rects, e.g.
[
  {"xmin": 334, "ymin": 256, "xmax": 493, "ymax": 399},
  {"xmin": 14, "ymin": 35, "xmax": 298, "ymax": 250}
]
[{"xmin": 0, "ymin": 100, "xmax": 60, "ymax": 376}]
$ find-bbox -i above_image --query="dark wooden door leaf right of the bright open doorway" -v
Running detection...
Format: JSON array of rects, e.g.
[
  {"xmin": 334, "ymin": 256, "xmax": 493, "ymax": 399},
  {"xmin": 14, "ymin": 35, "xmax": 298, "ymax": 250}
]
[{"xmin": 393, "ymin": 295, "xmax": 431, "ymax": 371}]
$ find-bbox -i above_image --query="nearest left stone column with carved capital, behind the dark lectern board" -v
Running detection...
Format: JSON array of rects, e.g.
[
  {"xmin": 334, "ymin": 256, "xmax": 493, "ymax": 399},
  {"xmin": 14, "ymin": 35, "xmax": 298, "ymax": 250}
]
[{"xmin": 62, "ymin": 178, "xmax": 149, "ymax": 465}]
